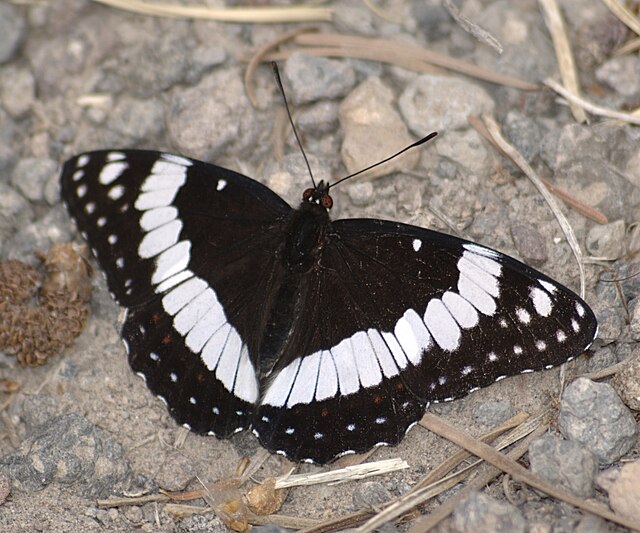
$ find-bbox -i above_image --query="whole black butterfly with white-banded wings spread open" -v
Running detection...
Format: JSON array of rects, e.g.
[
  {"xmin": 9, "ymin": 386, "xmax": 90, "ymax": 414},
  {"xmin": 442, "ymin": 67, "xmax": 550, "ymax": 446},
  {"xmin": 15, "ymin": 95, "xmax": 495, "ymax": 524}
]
[{"xmin": 61, "ymin": 150, "xmax": 597, "ymax": 463}]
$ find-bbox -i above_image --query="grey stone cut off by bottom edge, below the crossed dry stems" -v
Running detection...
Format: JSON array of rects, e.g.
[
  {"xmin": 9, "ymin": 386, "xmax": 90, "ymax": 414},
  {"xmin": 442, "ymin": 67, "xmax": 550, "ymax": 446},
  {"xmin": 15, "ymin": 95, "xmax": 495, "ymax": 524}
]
[{"xmin": 453, "ymin": 492, "xmax": 526, "ymax": 533}]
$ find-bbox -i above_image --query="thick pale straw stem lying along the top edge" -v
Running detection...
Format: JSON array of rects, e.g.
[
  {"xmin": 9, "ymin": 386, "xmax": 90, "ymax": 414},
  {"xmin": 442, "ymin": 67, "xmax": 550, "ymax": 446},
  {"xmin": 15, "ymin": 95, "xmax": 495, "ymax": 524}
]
[{"xmin": 93, "ymin": 0, "xmax": 333, "ymax": 24}]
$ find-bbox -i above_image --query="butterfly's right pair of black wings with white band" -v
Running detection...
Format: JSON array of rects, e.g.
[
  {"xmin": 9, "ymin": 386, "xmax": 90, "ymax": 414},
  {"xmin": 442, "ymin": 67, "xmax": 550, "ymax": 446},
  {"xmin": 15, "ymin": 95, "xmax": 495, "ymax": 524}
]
[{"xmin": 254, "ymin": 216, "xmax": 597, "ymax": 463}]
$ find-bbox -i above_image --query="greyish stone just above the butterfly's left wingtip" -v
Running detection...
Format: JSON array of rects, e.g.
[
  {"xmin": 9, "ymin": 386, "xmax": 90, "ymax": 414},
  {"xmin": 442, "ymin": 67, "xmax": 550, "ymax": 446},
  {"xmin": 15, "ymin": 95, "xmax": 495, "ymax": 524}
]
[{"xmin": 103, "ymin": 96, "xmax": 165, "ymax": 146}]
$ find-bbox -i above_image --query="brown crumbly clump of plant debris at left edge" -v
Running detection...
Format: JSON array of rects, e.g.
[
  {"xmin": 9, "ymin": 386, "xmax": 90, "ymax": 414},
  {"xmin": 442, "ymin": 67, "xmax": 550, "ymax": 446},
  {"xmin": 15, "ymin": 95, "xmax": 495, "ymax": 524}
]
[{"xmin": 0, "ymin": 244, "xmax": 91, "ymax": 366}]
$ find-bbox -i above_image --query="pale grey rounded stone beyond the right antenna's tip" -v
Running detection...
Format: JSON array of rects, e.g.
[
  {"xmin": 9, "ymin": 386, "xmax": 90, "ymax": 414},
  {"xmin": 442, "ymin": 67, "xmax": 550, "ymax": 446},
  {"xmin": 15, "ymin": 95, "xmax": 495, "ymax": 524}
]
[{"xmin": 398, "ymin": 74, "xmax": 495, "ymax": 136}]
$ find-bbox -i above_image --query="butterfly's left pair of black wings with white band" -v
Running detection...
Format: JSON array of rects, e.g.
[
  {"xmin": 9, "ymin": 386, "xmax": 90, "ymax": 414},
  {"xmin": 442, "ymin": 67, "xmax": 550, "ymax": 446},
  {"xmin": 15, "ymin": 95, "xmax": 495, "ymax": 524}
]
[{"xmin": 61, "ymin": 150, "xmax": 291, "ymax": 437}]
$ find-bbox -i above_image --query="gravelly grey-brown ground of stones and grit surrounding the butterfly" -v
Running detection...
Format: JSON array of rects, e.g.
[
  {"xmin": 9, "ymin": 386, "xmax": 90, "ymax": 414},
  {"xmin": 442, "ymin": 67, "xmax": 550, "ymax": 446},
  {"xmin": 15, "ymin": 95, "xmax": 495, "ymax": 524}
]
[{"xmin": 0, "ymin": 0, "xmax": 640, "ymax": 533}]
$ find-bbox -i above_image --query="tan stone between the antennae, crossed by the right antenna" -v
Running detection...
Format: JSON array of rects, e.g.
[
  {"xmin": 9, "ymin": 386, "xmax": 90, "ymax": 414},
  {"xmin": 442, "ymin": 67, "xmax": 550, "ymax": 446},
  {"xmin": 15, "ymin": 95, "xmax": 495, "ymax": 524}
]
[{"xmin": 340, "ymin": 78, "xmax": 426, "ymax": 178}]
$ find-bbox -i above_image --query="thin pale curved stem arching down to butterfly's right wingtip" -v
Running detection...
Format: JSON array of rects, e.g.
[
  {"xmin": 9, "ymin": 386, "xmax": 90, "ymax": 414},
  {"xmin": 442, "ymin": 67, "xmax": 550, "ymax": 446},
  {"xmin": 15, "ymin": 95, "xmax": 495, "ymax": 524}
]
[{"xmin": 483, "ymin": 115, "xmax": 585, "ymax": 298}]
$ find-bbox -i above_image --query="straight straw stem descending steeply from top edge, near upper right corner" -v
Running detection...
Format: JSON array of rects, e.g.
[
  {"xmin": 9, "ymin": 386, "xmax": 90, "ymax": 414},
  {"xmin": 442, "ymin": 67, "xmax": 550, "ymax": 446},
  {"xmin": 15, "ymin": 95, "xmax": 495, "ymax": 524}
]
[{"xmin": 538, "ymin": 0, "xmax": 587, "ymax": 123}]
